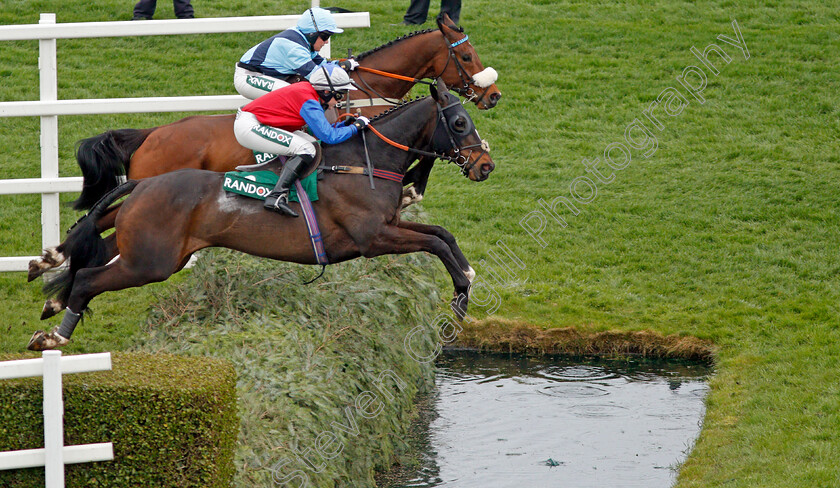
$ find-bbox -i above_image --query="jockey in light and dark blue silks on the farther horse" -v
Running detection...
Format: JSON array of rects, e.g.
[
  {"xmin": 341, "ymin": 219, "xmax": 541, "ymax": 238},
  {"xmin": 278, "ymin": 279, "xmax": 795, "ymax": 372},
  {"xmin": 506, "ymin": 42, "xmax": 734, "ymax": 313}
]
[{"xmin": 233, "ymin": 7, "xmax": 358, "ymax": 100}]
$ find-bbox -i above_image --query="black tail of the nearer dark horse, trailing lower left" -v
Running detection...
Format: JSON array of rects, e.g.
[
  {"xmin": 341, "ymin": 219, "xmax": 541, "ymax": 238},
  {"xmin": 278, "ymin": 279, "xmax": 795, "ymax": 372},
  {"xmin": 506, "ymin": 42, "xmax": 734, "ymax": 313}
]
[{"xmin": 44, "ymin": 180, "xmax": 139, "ymax": 304}]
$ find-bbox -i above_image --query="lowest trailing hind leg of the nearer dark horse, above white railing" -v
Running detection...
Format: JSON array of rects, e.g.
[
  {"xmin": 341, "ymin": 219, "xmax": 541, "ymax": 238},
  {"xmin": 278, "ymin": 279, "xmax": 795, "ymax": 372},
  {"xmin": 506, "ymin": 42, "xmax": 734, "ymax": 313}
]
[{"xmin": 28, "ymin": 259, "xmax": 174, "ymax": 351}]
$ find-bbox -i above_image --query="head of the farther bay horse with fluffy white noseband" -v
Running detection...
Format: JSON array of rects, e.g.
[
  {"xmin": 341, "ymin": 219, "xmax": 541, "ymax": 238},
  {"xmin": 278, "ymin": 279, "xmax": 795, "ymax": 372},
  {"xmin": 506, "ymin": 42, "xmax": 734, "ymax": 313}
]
[{"xmin": 437, "ymin": 13, "xmax": 502, "ymax": 110}]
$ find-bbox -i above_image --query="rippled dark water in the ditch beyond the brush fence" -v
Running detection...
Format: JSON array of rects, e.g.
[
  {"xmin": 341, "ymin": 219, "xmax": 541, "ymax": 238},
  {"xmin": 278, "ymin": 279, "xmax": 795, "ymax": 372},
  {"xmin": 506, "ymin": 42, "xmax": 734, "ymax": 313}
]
[{"xmin": 380, "ymin": 352, "xmax": 711, "ymax": 488}]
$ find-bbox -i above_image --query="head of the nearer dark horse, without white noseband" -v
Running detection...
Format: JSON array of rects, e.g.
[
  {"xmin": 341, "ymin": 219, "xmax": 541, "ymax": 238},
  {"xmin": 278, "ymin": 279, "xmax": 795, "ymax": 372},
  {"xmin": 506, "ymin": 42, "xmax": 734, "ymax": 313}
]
[{"xmin": 430, "ymin": 78, "xmax": 496, "ymax": 181}]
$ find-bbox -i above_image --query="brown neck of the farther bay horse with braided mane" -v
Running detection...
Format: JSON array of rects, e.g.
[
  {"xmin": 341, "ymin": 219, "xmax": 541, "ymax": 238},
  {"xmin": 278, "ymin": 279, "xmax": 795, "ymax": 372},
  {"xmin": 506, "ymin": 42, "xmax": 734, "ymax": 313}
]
[{"xmin": 359, "ymin": 30, "xmax": 449, "ymax": 98}]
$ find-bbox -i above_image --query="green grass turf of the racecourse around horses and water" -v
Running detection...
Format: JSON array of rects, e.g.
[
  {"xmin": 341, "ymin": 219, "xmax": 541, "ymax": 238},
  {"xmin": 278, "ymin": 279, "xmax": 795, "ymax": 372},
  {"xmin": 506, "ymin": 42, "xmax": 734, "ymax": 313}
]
[{"xmin": 0, "ymin": 0, "xmax": 840, "ymax": 488}]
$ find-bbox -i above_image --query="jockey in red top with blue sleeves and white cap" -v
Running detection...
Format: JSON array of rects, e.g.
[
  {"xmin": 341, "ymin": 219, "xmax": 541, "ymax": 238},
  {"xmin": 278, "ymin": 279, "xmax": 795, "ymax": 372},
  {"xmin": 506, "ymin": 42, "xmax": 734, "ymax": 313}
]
[{"xmin": 233, "ymin": 64, "xmax": 369, "ymax": 217}]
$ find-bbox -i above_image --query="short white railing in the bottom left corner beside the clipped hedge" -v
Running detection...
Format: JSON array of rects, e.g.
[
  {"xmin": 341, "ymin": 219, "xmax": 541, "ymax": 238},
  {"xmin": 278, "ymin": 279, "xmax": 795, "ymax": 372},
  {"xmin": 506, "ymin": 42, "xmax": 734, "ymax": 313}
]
[{"xmin": 0, "ymin": 351, "xmax": 114, "ymax": 488}]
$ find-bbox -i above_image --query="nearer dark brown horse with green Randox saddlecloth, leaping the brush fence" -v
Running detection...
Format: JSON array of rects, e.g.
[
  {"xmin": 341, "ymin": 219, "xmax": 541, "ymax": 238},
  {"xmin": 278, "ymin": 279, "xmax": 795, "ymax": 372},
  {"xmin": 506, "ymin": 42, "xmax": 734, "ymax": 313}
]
[{"xmin": 29, "ymin": 82, "xmax": 495, "ymax": 350}]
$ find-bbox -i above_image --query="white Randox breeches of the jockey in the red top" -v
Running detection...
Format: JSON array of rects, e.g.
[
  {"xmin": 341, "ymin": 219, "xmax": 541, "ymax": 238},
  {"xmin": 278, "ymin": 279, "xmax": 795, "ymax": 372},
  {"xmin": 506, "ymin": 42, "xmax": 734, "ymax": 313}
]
[{"xmin": 233, "ymin": 110, "xmax": 317, "ymax": 156}]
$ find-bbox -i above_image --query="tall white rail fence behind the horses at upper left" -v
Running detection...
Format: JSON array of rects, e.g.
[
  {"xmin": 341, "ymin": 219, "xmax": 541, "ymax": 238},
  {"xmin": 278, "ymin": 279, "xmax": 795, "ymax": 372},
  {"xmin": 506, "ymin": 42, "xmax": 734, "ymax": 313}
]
[{"xmin": 0, "ymin": 9, "xmax": 370, "ymax": 271}]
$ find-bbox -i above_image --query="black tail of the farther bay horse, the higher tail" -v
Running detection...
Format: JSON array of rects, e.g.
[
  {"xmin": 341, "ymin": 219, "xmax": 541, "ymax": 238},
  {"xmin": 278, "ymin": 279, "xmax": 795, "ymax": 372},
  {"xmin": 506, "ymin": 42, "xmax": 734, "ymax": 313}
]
[{"xmin": 73, "ymin": 127, "xmax": 156, "ymax": 210}]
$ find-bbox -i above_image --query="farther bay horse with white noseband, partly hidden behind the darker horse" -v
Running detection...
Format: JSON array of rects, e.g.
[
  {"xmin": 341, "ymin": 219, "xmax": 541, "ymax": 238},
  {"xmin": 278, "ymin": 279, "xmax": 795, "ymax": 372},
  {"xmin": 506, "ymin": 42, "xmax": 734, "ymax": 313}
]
[{"xmin": 74, "ymin": 14, "xmax": 501, "ymax": 210}]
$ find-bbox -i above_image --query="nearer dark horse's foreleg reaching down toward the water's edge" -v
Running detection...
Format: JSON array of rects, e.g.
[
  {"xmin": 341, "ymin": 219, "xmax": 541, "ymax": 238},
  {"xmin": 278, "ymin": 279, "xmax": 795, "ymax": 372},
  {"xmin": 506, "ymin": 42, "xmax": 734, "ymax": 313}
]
[{"xmin": 364, "ymin": 226, "xmax": 470, "ymax": 319}]
